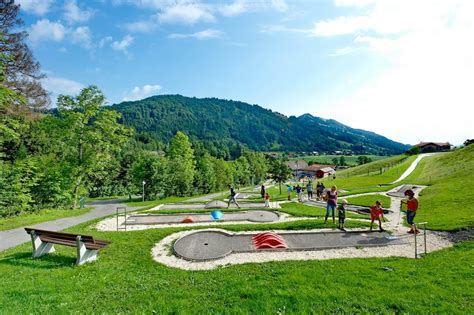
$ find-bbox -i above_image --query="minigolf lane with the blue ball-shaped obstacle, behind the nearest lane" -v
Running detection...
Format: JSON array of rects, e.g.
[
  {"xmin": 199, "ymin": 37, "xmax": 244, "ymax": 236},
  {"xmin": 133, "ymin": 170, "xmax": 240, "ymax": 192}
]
[{"xmin": 127, "ymin": 210, "xmax": 280, "ymax": 225}]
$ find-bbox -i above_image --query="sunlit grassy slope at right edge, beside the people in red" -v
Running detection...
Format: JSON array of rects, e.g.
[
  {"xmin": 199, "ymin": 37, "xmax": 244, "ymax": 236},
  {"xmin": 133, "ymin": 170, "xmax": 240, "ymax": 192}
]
[{"xmin": 396, "ymin": 145, "xmax": 474, "ymax": 230}]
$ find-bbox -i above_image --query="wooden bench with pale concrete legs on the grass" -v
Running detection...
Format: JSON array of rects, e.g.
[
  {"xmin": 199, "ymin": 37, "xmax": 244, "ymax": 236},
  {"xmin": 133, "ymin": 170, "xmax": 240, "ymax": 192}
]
[{"xmin": 25, "ymin": 228, "xmax": 112, "ymax": 265}]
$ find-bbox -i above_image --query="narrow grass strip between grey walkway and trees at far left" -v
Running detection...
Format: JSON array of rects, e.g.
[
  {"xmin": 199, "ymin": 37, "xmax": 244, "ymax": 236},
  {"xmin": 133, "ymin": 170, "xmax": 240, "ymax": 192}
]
[{"xmin": 0, "ymin": 207, "xmax": 92, "ymax": 231}]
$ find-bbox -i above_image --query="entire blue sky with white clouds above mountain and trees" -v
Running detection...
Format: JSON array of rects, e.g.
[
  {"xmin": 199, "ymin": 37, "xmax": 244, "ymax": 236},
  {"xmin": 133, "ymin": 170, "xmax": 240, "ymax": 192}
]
[{"xmin": 18, "ymin": 0, "xmax": 474, "ymax": 144}]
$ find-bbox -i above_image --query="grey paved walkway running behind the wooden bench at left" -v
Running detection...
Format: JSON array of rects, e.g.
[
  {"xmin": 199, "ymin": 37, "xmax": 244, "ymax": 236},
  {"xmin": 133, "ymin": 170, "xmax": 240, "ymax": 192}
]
[{"xmin": 0, "ymin": 200, "xmax": 137, "ymax": 251}]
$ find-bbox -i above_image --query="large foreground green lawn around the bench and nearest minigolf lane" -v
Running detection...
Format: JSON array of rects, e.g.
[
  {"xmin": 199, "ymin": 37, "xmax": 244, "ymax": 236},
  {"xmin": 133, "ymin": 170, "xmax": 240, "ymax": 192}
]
[{"xmin": 0, "ymin": 221, "xmax": 474, "ymax": 314}]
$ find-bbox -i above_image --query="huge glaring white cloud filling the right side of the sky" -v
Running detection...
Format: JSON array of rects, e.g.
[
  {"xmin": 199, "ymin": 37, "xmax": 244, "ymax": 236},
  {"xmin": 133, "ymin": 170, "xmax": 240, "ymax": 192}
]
[{"xmin": 314, "ymin": 0, "xmax": 474, "ymax": 144}]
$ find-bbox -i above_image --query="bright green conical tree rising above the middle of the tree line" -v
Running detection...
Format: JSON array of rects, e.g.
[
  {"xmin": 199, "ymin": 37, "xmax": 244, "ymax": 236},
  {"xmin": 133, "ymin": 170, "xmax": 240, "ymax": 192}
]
[{"xmin": 167, "ymin": 131, "xmax": 196, "ymax": 196}]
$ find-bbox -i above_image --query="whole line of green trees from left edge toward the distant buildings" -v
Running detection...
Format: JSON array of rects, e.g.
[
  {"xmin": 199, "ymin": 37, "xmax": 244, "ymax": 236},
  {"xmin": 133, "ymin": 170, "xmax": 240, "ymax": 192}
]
[{"xmin": 0, "ymin": 1, "xmax": 290, "ymax": 217}]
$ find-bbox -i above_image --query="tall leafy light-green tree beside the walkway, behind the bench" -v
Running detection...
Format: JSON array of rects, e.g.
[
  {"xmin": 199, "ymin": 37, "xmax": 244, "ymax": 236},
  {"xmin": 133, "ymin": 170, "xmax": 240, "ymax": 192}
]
[{"xmin": 57, "ymin": 85, "xmax": 131, "ymax": 207}]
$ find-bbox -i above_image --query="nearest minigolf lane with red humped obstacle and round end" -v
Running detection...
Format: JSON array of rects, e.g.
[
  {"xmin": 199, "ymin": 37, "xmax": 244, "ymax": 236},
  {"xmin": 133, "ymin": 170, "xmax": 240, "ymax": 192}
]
[{"xmin": 173, "ymin": 230, "xmax": 406, "ymax": 261}]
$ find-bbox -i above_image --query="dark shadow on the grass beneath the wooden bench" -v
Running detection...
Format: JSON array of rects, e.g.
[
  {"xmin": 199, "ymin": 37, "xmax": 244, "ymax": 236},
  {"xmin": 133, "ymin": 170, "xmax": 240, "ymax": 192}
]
[{"xmin": 0, "ymin": 252, "xmax": 76, "ymax": 269}]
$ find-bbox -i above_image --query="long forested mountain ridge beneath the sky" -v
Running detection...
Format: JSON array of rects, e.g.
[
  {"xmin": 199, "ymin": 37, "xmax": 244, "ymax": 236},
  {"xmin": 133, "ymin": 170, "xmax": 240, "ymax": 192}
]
[{"xmin": 112, "ymin": 95, "xmax": 408, "ymax": 156}]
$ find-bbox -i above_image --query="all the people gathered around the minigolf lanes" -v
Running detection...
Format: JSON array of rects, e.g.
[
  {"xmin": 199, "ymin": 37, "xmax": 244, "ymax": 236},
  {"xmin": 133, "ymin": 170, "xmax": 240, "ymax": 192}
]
[{"xmin": 227, "ymin": 182, "xmax": 420, "ymax": 234}]
